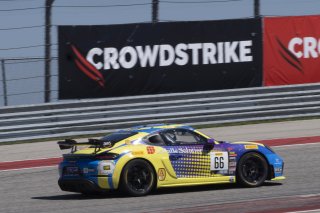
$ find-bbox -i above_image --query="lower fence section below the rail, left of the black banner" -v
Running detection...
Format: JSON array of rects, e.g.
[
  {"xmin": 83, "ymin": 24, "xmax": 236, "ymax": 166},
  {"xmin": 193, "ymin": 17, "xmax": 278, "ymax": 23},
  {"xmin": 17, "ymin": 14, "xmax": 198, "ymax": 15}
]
[{"xmin": 0, "ymin": 58, "xmax": 58, "ymax": 106}]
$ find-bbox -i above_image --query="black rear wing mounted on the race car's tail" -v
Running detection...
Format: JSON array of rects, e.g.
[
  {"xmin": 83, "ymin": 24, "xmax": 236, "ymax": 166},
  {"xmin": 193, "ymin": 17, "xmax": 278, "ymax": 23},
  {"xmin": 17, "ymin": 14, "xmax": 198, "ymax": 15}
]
[{"xmin": 58, "ymin": 139, "xmax": 114, "ymax": 154}]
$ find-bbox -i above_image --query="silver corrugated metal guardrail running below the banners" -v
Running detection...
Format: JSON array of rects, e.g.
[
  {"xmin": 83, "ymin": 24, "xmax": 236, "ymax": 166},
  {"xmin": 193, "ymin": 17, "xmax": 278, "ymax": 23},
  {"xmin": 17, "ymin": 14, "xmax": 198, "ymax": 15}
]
[{"xmin": 0, "ymin": 84, "xmax": 320, "ymax": 142}]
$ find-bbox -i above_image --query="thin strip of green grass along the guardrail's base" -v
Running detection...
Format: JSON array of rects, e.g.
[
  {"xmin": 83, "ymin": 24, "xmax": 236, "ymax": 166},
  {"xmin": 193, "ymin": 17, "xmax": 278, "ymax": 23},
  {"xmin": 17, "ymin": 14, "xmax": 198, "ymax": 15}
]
[{"xmin": 0, "ymin": 116, "xmax": 320, "ymax": 146}]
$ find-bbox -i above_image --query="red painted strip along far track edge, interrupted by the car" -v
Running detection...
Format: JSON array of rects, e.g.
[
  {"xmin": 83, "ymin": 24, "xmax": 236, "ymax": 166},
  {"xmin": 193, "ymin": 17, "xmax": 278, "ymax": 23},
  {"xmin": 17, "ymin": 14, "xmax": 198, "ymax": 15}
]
[{"xmin": 0, "ymin": 136, "xmax": 320, "ymax": 171}]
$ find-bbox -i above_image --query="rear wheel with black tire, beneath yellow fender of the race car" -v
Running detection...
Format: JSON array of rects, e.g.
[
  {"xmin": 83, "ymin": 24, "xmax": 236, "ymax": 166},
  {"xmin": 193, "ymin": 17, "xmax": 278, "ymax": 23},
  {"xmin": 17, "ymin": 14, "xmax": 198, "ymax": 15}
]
[{"xmin": 120, "ymin": 159, "xmax": 156, "ymax": 197}]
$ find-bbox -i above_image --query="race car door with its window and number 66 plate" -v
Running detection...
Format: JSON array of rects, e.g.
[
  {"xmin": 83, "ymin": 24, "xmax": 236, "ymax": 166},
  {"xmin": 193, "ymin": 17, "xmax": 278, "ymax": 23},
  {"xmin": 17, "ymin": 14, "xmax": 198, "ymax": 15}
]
[{"xmin": 160, "ymin": 129, "xmax": 220, "ymax": 178}]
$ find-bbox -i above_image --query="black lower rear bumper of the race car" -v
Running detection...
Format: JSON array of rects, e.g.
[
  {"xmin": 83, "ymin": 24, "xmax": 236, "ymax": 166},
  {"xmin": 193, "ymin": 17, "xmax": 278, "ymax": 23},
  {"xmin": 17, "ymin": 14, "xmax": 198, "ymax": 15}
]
[{"xmin": 58, "ymin": 178, "xmax": 107, "ymax": 193}]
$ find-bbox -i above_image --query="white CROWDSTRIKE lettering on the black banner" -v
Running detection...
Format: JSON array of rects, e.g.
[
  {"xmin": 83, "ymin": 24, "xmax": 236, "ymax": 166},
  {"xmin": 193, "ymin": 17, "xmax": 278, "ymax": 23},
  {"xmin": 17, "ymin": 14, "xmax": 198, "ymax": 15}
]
[{"xmin": 86, "ymin": 40, "xmax": 254, "ymax": 70}]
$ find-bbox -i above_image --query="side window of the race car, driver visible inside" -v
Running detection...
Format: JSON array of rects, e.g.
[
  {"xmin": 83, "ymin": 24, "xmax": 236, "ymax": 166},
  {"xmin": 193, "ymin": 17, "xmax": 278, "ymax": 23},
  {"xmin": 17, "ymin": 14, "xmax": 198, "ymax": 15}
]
[{"xmin": 162, "ymin": 129, "xmax": 206, "ymax": 145}]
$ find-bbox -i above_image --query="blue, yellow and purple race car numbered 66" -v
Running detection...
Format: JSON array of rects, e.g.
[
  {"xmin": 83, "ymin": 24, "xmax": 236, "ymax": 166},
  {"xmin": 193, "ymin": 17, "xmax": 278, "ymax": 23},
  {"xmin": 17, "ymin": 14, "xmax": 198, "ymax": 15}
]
[{"xmin": 58, "ymin": 124, "xmax": 285, "ymax": 196}]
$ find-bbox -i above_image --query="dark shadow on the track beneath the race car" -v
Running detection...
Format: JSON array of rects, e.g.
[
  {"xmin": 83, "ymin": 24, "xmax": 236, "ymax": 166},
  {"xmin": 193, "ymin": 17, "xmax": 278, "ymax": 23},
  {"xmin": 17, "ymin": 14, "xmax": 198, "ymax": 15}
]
[{"xmin": 31, "ymin": 182, "xmax": 282, "ymax": 200}]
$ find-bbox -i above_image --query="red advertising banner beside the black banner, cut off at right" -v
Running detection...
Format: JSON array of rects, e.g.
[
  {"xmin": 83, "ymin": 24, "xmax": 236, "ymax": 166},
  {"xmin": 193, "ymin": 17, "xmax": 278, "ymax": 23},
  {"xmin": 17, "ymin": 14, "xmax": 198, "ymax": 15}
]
[{"xmin": 263, "ymin": 16, "xmax": 320, "ymax": 86}]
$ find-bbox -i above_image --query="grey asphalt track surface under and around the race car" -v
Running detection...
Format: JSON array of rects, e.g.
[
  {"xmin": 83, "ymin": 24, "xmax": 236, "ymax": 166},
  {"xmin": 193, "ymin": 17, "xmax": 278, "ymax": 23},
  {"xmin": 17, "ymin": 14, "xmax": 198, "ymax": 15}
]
[{"xmin": 0, "ymin": 120, "xmax": 320, "ymax": 213}]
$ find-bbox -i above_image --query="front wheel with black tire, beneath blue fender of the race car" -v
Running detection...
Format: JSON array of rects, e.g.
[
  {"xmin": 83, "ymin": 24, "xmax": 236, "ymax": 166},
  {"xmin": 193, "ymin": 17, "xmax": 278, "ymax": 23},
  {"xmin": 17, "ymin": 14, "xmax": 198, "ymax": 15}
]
[{"xmin": 237, "ymin": 152, "xmax": 268, "ymax": 187}]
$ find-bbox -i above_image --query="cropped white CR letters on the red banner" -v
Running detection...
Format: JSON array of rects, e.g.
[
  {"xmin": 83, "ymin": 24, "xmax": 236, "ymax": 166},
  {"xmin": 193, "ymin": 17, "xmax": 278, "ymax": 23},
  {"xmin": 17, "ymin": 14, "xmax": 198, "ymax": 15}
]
[{"xmin": 288, "ymin": 37, "xmax": 320, "ymax": 58}]
